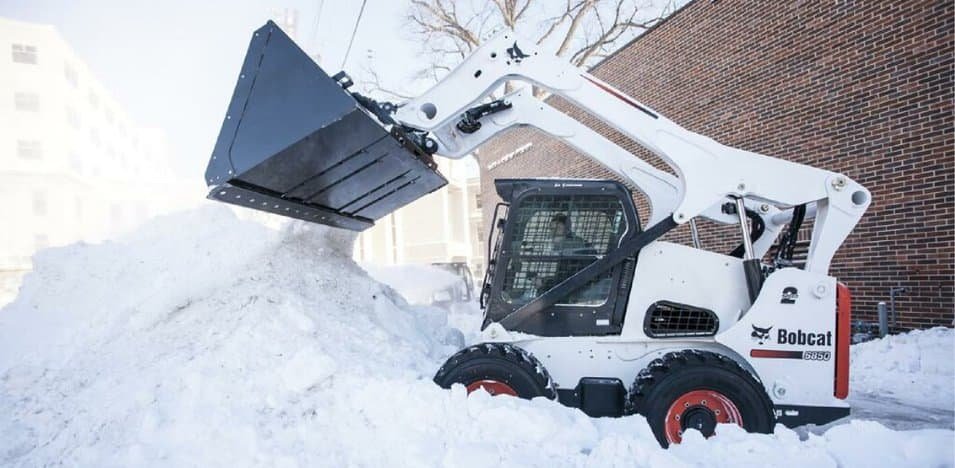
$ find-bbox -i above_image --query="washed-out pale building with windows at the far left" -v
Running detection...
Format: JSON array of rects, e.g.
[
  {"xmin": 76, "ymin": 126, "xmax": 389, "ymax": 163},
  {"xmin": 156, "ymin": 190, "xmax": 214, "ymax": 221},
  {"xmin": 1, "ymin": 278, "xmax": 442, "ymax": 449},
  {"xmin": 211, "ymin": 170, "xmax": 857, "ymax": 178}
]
[{"xmin": 0, "ymin": 18, "xmax": 196, "ymax": 272}]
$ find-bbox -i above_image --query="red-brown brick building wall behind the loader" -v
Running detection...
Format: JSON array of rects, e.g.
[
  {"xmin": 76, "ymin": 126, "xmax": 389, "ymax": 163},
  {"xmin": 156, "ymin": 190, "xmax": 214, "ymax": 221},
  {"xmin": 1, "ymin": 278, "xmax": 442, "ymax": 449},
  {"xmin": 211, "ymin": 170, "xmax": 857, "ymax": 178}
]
[{"xmin": 478, "ymin": 0, "xmax": 955, "ymax": 327}]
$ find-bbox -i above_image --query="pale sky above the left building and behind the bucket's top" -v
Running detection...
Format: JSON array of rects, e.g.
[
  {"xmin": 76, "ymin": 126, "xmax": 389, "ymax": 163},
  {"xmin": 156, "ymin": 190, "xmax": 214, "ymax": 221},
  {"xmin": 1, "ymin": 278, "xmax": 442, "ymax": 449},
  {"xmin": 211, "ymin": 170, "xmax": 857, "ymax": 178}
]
[{"xmin": 0, "ymin": 0, "xmax": 418, "ymax": 178}]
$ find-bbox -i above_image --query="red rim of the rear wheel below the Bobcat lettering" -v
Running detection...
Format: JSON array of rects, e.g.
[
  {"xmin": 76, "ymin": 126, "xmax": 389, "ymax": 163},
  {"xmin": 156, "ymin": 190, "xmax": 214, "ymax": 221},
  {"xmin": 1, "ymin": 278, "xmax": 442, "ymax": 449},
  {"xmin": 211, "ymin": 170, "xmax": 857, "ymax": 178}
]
[{"xmin": 664, "ymin": 390, "xmax": 743, "ymax": 444}]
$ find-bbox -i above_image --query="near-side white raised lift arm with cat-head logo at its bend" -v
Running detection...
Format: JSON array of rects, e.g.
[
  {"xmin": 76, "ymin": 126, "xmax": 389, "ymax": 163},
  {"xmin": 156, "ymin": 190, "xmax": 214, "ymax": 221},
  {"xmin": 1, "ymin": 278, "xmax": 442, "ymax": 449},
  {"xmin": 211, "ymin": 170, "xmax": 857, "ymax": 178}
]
[{"xmin": 395, "ymin": 31, "xmax": 871, "ymax": 274}]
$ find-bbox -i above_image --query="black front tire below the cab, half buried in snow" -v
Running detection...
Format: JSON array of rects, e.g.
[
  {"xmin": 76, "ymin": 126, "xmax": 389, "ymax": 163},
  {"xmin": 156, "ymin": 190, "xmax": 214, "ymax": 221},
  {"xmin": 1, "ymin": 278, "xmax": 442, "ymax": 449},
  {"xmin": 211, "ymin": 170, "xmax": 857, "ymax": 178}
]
[{"xmin": 434, "ymin": 343, "xmax": 557, "ymax": 400}]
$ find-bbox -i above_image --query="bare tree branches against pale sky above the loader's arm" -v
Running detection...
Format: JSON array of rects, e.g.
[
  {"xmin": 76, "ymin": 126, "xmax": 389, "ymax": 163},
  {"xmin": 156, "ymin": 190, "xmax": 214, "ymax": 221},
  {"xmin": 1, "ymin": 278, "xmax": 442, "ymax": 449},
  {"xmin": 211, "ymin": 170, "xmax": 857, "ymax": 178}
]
[{"xmin": 365, "ymin": 0, "xmax": 675, "ymax": 97}]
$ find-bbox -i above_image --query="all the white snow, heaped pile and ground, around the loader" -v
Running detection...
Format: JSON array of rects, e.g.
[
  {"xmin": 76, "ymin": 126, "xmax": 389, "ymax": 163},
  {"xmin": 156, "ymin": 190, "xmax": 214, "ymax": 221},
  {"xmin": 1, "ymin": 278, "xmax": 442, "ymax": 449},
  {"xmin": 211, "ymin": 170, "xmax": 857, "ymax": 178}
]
[{"xmin": 0, "ymin": 207, "xmax": 955, "ymax": 467}]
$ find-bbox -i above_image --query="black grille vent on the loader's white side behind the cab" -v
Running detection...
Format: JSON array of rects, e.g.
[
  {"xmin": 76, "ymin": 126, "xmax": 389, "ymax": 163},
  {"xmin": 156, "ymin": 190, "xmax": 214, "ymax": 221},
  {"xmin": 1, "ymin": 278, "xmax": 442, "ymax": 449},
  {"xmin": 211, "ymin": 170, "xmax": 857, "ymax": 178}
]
[{"xmin": 643, "ymin": 301, "xmax": 720, "ymax": 338}]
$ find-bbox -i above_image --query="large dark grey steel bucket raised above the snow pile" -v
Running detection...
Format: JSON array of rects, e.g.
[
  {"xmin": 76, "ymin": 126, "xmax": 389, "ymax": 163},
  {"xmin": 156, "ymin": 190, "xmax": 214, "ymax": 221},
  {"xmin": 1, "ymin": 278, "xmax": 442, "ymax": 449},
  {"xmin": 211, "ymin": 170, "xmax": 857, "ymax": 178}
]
[{"xmin": 206, "ymin": 21, "xmax": 447, "ymax": 231}]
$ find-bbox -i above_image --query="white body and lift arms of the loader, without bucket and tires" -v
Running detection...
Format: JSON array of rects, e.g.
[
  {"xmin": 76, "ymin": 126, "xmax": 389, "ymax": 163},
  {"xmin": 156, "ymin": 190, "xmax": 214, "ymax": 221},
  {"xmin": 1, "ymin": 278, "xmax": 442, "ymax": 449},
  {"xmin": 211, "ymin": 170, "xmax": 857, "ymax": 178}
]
[{"xmin": 384, "ymin": 31, "xmax": 871, "ymax": 425}]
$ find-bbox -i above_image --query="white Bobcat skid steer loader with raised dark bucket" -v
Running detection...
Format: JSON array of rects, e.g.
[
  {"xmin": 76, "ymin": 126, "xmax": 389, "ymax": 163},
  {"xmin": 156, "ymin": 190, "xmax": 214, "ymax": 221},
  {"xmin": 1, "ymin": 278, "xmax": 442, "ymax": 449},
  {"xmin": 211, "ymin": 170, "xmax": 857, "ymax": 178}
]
[{"xmin": 206, "ymin": 22, "xmax": 870, "ymax": 446}]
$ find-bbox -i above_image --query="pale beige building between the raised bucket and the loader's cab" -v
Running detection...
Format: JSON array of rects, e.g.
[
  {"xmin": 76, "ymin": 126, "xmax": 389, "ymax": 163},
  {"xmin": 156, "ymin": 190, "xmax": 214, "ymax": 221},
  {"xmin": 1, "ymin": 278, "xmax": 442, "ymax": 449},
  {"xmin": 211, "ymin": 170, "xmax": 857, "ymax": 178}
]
[{"xmin": 355, "ymin": 158, "xmax": 484, "ymax": 281}]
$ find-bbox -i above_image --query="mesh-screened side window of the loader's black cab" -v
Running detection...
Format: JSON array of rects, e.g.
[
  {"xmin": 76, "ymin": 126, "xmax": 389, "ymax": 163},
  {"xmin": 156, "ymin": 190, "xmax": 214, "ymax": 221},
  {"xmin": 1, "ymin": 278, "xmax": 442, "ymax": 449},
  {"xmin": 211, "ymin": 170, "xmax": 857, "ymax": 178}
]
[{"xmin": 502, "ymin": 195, "xmax": 626, "ymax": 306}]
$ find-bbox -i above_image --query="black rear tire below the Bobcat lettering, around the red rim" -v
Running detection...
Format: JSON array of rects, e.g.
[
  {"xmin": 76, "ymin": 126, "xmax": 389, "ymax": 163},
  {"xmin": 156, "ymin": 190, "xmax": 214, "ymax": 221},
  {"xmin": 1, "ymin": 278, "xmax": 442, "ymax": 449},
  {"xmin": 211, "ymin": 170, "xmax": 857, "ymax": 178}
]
[{"xmin": 628, "ymin": 349, "xmax": 776, "ymax": 448}]
